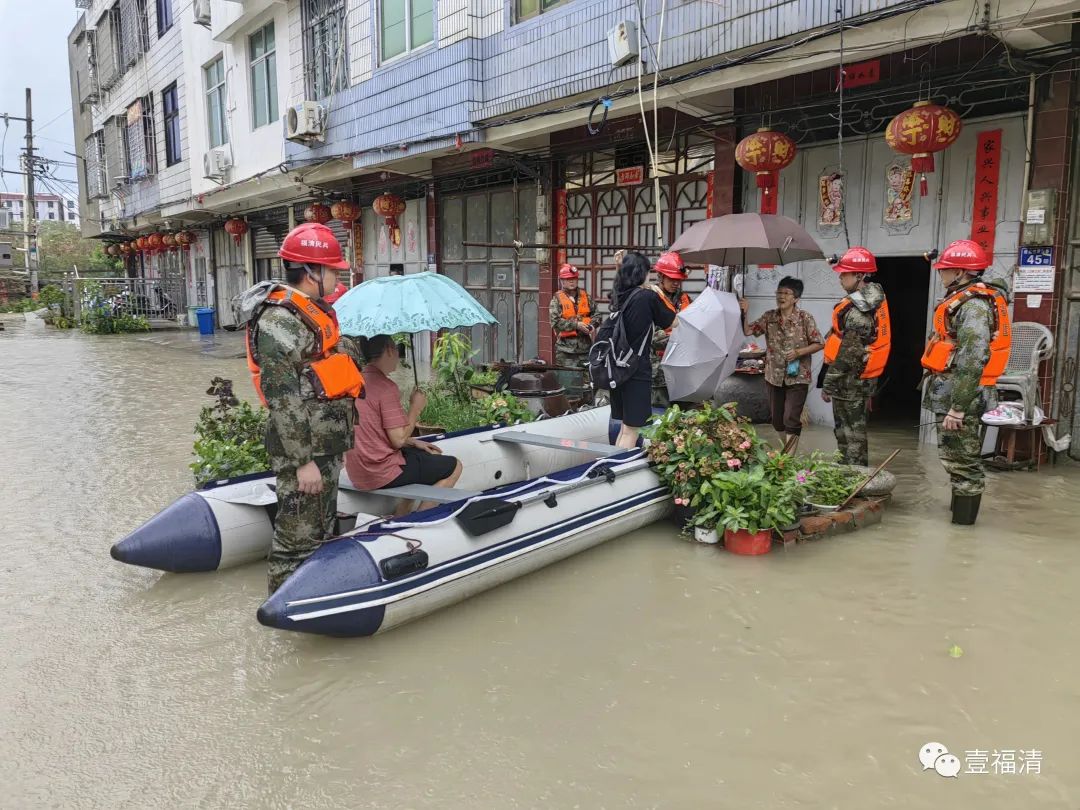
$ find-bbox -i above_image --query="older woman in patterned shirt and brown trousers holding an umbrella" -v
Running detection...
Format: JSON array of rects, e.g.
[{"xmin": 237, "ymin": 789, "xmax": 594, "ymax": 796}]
[{"xmin": 739, "ymin": 276, "xmax": 824, "ymax": 450}]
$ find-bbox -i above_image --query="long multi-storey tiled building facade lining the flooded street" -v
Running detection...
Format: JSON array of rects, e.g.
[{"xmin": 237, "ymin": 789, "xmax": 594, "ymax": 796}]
[{"xmin": 72, "ymin": 0, "xmax": 1080, "ymax": 457}]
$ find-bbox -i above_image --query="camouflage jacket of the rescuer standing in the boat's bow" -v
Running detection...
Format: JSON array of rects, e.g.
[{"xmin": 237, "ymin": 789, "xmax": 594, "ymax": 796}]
[{"xmin": 255, "ymin": 307, "xmax": 362, "ymax": 472}]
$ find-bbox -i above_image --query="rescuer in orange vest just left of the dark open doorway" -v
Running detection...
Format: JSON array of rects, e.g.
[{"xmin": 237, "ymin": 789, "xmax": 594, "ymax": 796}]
[{"xmin": 821, "ymin": 247, "xmax": 889, "ymax": 467}]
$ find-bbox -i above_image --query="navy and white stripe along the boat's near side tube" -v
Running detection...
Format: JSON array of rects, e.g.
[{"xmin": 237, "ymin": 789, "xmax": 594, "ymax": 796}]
[{"xmin": 286, "ymin": 487, "xmax": 671, "ymax": 621}]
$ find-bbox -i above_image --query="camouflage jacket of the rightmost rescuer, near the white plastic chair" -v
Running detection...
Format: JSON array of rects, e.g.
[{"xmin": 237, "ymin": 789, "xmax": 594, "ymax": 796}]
[{"xmin": 922, "ymin": 279, "xmax": 1008, "ymax": 416}]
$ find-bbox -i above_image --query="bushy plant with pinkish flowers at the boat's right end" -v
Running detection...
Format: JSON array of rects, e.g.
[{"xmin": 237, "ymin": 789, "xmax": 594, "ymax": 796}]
[{"xmin": 644, "ymin": 403, "xmax": 765, "ymax": 505}]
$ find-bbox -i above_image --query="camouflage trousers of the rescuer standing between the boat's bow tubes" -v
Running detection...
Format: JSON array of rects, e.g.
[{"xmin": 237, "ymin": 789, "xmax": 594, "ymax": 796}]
[{"xmin": 267, "ymin": 456, "xmax": 341, "ymax": 593}]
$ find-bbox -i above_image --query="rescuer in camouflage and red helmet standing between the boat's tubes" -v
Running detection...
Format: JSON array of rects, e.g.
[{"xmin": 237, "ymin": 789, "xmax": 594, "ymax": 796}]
[{"xmin": 242, "ymin": 222, "xmax": 362, "ymax": 594}]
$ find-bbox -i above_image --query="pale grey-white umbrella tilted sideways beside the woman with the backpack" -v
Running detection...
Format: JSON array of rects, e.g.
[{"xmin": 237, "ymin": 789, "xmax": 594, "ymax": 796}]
[{"xmin": 660, "ymin": 287, "xmax": 743, "ymax": 402}]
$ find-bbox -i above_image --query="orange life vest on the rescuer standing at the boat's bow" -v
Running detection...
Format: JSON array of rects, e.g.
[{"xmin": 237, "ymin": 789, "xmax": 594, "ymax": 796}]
[{"xmin": 246, "ymin": 287, "xmax": 364, "ymax": 405}]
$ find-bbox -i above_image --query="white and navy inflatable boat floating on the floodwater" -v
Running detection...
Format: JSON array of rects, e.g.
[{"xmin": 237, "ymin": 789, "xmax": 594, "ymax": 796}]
[{"xmin": 112, "ymin": 407, "xmax": 670, "ymax": 587}]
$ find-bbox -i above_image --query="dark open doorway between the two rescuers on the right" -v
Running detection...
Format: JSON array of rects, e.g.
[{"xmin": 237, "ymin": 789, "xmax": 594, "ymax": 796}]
[{"xmin": 872, "ymin": 256, "xmax": 930, "ymax": 427}]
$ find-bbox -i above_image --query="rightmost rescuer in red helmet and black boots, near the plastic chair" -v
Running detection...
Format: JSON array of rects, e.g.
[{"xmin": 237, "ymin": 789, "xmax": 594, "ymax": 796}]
[{"xmin": 922, "ymin": 240, "xmax": 1011, "ymax": 525}]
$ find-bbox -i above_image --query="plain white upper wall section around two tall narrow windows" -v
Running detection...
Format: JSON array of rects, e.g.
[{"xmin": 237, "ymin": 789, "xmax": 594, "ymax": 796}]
[{"xmin": 184, "ymin": 0, "xmax": 296, "ymax": 198}]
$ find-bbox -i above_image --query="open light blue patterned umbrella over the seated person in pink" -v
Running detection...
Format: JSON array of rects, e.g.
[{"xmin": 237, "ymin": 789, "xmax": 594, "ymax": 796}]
[{"xmin": 334, "ymin": 272, "xmax": 498, "ymax": 378}]
